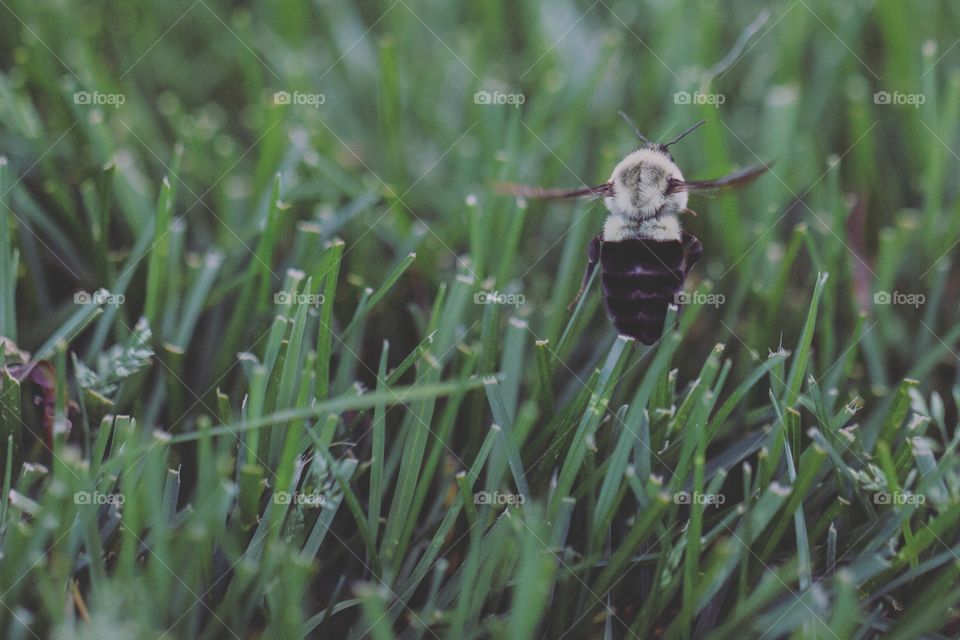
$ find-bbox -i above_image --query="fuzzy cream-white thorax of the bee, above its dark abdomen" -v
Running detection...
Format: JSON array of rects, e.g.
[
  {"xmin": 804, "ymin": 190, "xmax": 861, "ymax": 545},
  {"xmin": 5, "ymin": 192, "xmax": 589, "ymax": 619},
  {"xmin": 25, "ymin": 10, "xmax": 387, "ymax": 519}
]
[{"xmin": 603, "ymin": 147, "xmax": 687, "ymax": 241}]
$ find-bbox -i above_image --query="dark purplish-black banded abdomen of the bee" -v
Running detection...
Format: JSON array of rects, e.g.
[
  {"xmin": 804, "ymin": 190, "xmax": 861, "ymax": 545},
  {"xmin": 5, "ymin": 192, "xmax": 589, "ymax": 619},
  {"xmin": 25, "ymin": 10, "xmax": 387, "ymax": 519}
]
[{"xmin": 600, "ymin": 239, "xmax": 702, "ymax": 344}]
